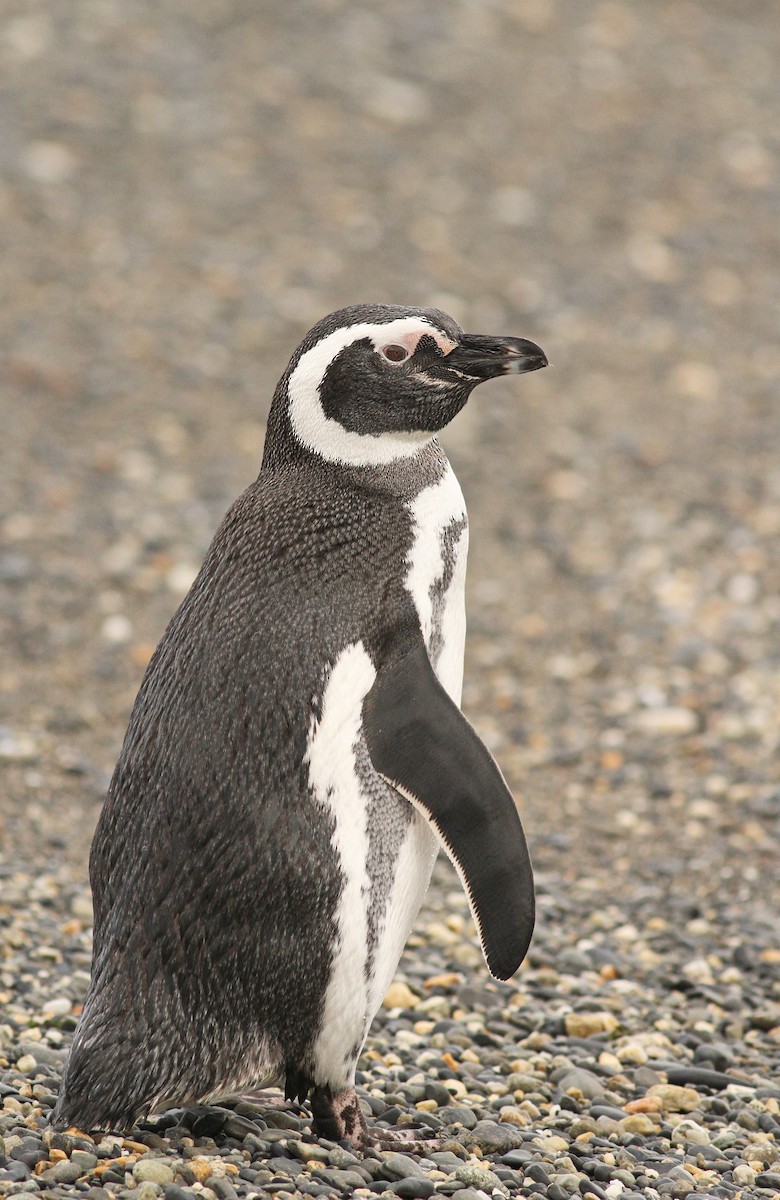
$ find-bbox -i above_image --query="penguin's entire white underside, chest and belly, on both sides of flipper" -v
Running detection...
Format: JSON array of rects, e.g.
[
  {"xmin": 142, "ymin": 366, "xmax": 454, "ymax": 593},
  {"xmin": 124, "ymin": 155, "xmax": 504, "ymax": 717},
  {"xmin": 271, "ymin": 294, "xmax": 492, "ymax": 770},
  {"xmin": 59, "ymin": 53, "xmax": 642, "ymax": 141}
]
[{"xmin": 307, "ymin": 464, "xmax": 468, "ymax": 1090}]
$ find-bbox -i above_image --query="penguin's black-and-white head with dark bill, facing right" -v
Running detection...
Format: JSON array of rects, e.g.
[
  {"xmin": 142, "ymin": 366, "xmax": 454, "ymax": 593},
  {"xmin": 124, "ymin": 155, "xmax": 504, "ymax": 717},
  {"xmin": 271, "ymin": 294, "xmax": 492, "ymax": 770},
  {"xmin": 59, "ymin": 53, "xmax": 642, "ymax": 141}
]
[{"xmin": 266, "ymin": 305, "xmax": 547, "ymax": 467}]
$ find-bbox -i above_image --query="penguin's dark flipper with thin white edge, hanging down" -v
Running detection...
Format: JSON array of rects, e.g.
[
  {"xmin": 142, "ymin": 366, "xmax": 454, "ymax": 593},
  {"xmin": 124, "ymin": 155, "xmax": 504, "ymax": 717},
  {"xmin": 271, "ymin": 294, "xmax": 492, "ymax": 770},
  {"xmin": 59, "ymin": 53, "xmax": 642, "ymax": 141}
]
[{"xmin": 364, "ymin": 641, "xmax": 534, "ymax": 979}]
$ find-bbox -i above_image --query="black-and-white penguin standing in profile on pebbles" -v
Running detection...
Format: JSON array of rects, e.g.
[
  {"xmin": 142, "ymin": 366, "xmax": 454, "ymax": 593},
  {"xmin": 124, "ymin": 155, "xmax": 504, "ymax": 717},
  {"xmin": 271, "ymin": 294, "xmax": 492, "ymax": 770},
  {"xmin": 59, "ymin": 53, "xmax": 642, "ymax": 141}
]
[{"xmin": 53, "ymin": 305, "xmax": 547, "ymax": 1146}]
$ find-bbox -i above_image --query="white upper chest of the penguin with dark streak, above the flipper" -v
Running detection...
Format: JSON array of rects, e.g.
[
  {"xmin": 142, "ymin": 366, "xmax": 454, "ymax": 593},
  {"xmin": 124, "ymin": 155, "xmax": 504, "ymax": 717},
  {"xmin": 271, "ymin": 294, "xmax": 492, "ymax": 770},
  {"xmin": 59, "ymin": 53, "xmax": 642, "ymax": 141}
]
[{"xmin": 404, "ymin": 463, "xmax": 468, "ymax": 704}]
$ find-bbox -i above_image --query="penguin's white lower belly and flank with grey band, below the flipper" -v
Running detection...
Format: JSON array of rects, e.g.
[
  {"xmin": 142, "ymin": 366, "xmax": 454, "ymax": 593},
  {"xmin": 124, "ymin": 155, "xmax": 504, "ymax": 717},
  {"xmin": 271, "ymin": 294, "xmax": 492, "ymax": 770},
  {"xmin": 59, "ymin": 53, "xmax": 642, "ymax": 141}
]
[{"xmin": 306, "ymin": 642, "xmax": 437, "ymax": 1090}]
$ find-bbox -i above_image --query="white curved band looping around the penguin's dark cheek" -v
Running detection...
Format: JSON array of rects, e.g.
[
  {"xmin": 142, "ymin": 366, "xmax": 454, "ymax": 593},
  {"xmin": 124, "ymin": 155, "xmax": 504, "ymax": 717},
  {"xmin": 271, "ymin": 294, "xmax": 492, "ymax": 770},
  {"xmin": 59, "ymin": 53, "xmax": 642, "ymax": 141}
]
[{"xmin": 287, "ymin": 317, "xmax": 457, "ymax": 467}]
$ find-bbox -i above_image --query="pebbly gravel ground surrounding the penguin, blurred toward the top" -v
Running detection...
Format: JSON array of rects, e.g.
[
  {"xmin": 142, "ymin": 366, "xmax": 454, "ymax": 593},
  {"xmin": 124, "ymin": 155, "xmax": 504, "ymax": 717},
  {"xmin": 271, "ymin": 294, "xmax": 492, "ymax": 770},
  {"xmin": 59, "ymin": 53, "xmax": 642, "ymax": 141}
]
[{"xmin": 0, "ymin": 0, "xmax": 780, "ymax": 1200}]
